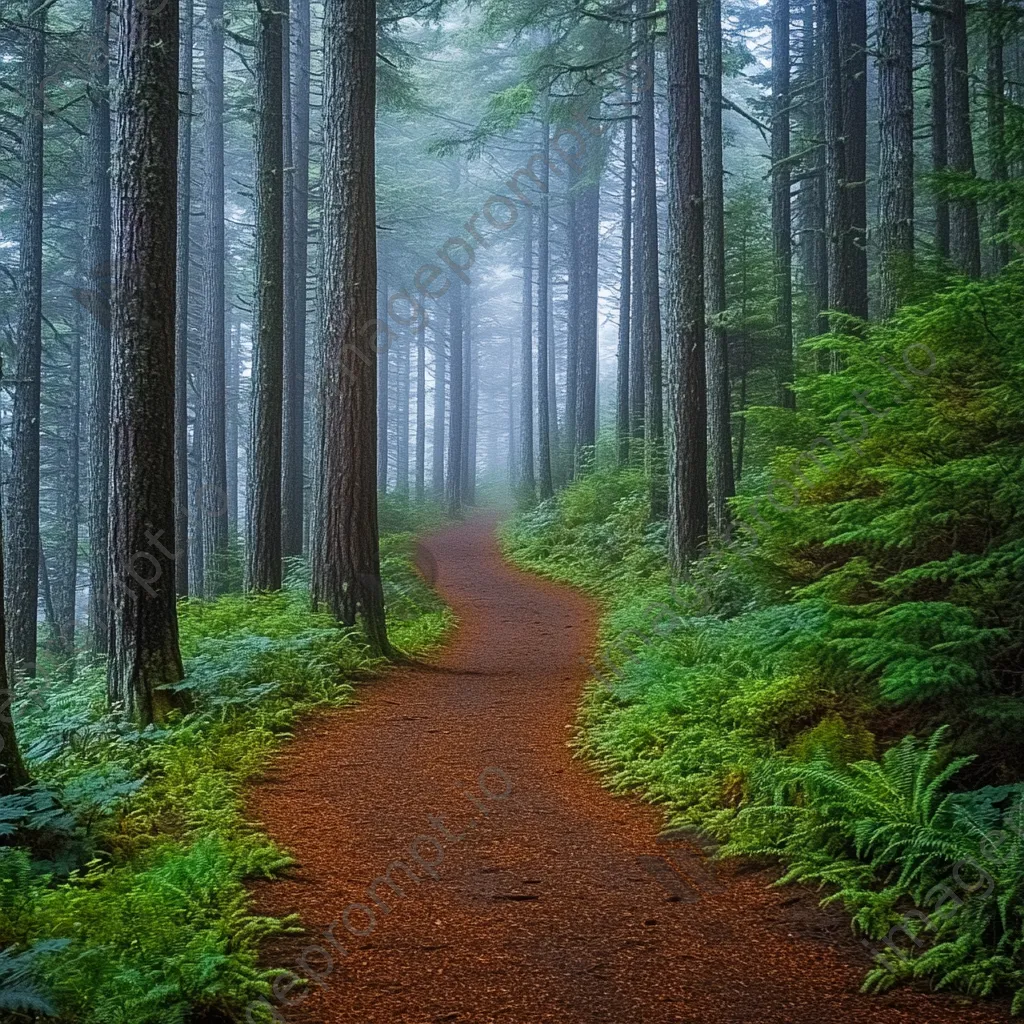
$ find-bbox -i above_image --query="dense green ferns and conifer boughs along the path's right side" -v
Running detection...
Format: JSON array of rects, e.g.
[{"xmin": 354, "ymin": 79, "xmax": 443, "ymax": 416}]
[{"xmin": 504, "ymin": 264, "xmax": 1024, "ymax": 1010}]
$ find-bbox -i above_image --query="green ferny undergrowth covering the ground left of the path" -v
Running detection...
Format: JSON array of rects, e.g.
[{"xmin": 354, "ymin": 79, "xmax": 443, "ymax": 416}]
[{"xmin": 0, "ymin": 516, "xmax": 451, "ymax": 1024}]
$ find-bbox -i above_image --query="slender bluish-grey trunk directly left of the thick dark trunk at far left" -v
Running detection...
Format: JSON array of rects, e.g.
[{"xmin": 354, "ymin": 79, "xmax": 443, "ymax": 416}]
[{"xmin": 85, "ymin": 0, "xmax": 111, "ymax": 654}]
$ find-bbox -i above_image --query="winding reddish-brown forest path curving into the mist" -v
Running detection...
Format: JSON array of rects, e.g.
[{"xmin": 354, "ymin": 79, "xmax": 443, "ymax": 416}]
[{"xmin": 252, "ymin": 518, "xmax": 1006, "ymax": 1024}]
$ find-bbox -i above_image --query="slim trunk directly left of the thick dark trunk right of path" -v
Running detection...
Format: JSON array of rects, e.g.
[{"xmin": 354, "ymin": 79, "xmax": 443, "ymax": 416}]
[{"xmin": 634, "ymin": 0, "xmax": 663, "ymax": 495}]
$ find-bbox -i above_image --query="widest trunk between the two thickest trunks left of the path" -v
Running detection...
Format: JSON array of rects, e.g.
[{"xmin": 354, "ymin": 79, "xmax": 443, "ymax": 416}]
[{"xmin": 246, "ymin": 0, "xmax": 284, "ymax": 591}]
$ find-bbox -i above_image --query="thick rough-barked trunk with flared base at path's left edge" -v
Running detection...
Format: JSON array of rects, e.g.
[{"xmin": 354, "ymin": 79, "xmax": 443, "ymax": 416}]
[{"xmin": 312, "ymin": 0, "xmax": 391, "ymax": 654}]
